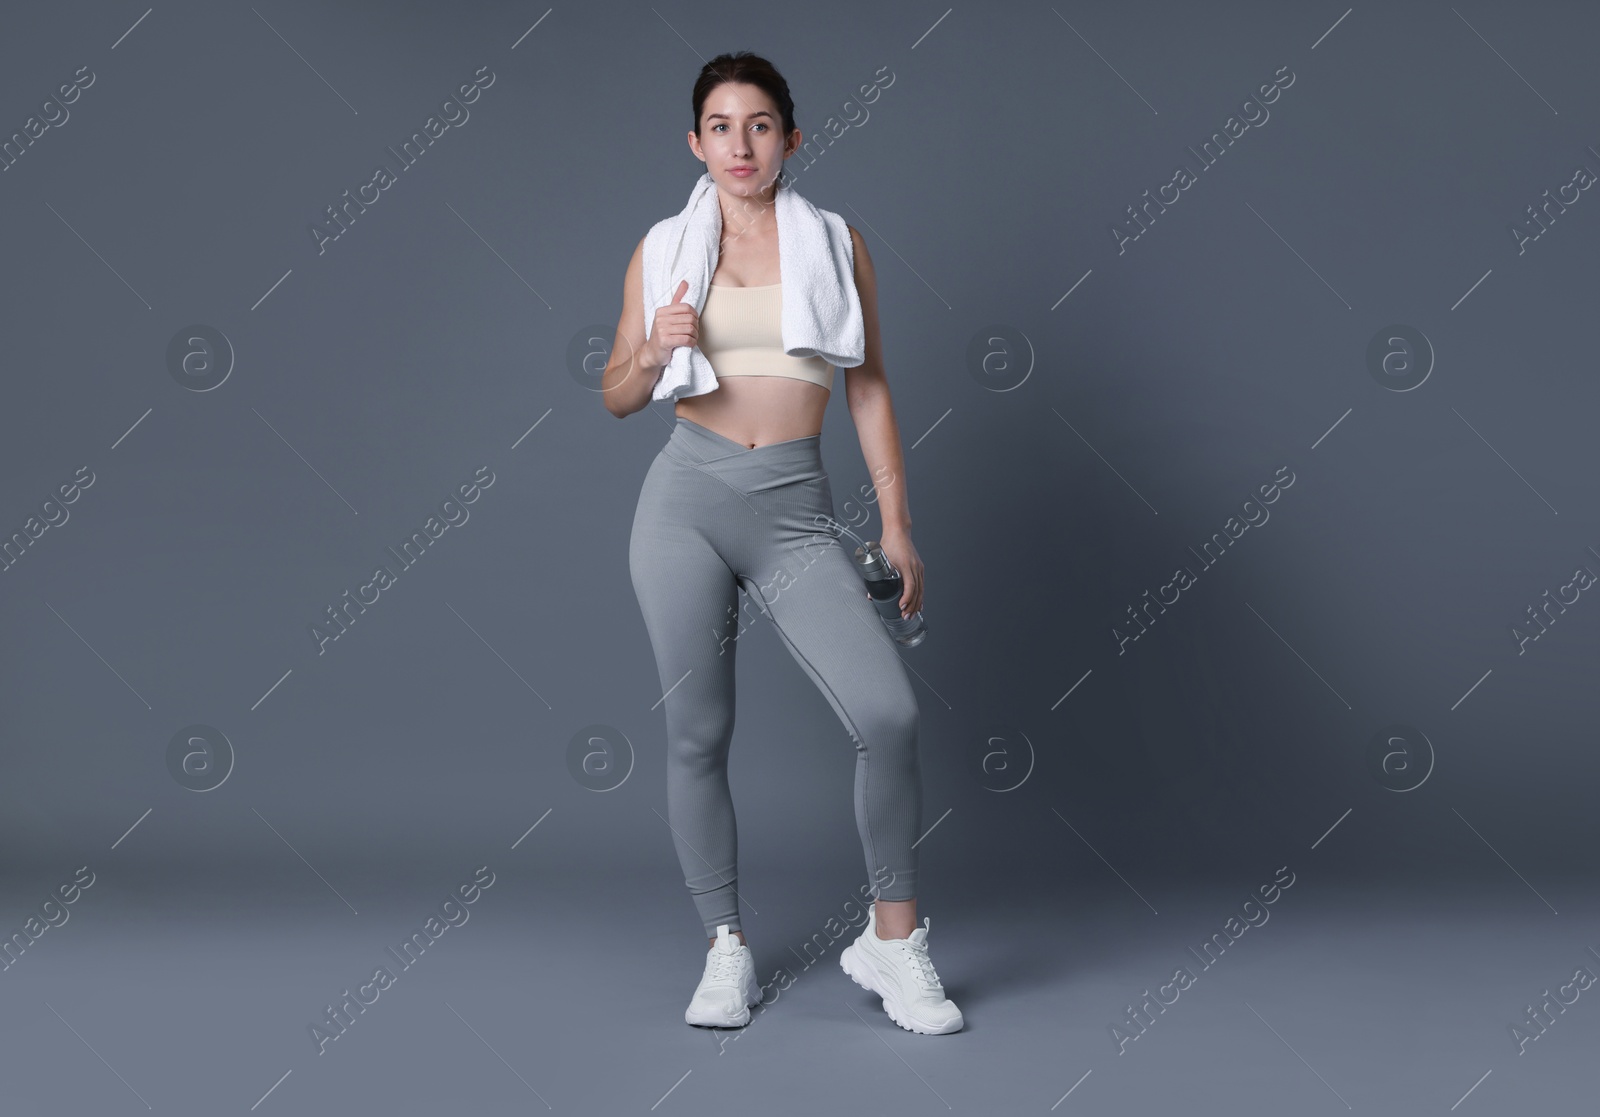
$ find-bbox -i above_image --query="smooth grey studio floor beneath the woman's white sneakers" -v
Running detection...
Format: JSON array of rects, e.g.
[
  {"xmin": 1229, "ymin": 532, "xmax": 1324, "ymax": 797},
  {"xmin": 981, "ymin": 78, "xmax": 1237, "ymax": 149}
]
[{"xmin": 0, "ymin": 867, "xmax": 1600, "ymax": 1117}]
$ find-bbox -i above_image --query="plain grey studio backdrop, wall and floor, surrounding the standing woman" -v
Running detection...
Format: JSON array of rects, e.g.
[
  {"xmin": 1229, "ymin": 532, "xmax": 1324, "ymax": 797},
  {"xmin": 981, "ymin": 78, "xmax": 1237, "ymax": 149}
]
[{"xmin": 0, "ymin": 3, "xmax": 1600, "ymax": 1114}]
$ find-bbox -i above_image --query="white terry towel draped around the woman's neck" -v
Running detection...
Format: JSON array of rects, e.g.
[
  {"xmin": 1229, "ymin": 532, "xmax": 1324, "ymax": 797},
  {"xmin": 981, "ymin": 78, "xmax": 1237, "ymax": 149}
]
[{"xmin": 642, "ymin": 171, "xmax": 867, "ymax": 400}]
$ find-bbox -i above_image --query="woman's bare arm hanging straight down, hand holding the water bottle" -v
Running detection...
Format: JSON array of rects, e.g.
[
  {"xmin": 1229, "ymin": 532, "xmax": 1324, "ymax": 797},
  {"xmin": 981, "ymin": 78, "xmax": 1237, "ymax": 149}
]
[{"xmin": 845, "ymin": 226, "xmax": 923, "ymax": 616}]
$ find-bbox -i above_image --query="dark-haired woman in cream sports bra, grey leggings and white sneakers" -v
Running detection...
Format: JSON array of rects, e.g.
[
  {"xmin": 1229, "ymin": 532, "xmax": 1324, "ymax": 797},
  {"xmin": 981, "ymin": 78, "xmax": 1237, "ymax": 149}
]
[{"xmin": 602, "ymin": 51, "xmax": 962, "ymax": 1034}]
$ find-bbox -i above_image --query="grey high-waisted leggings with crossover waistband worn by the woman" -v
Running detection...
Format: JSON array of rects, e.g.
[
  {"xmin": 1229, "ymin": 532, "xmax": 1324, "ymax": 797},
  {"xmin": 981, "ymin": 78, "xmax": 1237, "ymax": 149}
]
[{"xmin": 629, "ymin": 416, "xmax": 922, "ymax": 936}]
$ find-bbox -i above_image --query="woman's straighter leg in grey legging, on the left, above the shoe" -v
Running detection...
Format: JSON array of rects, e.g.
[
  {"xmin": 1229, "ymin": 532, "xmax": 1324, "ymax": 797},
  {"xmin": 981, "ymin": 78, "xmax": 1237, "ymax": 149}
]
[{"xmin": 629, "ymin": 461, "xmax": 744, "ymax": 941}]
